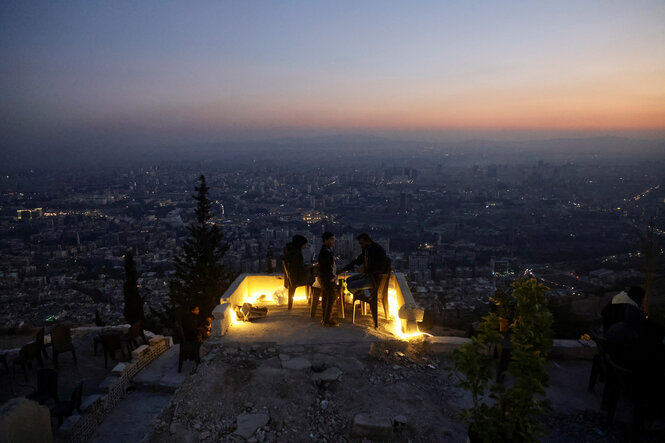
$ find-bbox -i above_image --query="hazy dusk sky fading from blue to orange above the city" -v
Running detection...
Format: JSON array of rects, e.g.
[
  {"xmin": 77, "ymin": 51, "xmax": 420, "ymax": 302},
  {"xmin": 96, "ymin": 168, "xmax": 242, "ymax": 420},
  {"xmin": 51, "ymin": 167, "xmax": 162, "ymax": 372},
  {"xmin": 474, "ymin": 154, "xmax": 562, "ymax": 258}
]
[{"xmin": 0, "ymin": 0, "xmax": 665, "ymax": 150}]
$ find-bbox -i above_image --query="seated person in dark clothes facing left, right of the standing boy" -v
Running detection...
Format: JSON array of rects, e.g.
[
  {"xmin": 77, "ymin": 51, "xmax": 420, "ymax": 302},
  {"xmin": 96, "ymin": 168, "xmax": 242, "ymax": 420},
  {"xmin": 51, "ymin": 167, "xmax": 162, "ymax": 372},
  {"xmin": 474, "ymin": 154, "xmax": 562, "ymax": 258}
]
[{"xmin": 343, "ymin": 233, "xmax": 390, "ymax": 328}]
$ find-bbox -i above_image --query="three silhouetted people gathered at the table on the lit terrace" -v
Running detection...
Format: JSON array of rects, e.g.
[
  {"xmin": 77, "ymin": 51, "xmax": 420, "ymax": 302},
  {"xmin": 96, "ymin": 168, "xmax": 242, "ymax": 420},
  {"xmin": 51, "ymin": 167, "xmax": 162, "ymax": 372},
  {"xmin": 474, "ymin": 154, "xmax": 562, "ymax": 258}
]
[{"xmin": 284, "ymin": 231, "xmax": 390, "ymax": 328}]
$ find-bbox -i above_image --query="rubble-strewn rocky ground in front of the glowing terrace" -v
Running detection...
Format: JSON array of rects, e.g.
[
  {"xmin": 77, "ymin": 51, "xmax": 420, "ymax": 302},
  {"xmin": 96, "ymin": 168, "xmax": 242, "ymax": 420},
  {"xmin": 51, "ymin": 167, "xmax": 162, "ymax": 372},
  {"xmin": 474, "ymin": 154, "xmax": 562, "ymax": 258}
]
[{"xmin": 149, "ymin": 341, "xmax": 466, "ymax": 442}]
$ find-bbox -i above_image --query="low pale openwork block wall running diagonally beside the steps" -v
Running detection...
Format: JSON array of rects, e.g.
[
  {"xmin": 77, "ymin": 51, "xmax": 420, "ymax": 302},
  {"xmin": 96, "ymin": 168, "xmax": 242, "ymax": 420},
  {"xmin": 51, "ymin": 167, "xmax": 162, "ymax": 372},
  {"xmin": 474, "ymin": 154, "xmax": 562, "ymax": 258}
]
[{"xmin": 58, "ymin": 335, "xmax": 173, "ymax": 442}]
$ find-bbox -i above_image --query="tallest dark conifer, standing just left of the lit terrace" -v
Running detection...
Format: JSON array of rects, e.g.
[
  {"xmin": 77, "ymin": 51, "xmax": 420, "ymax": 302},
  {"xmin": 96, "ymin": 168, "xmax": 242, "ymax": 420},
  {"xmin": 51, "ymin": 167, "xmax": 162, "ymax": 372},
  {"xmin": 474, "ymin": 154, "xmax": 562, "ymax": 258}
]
[{"xmin": 171, "ymin": 174, "xmax": 229, "ymax": 317}]
